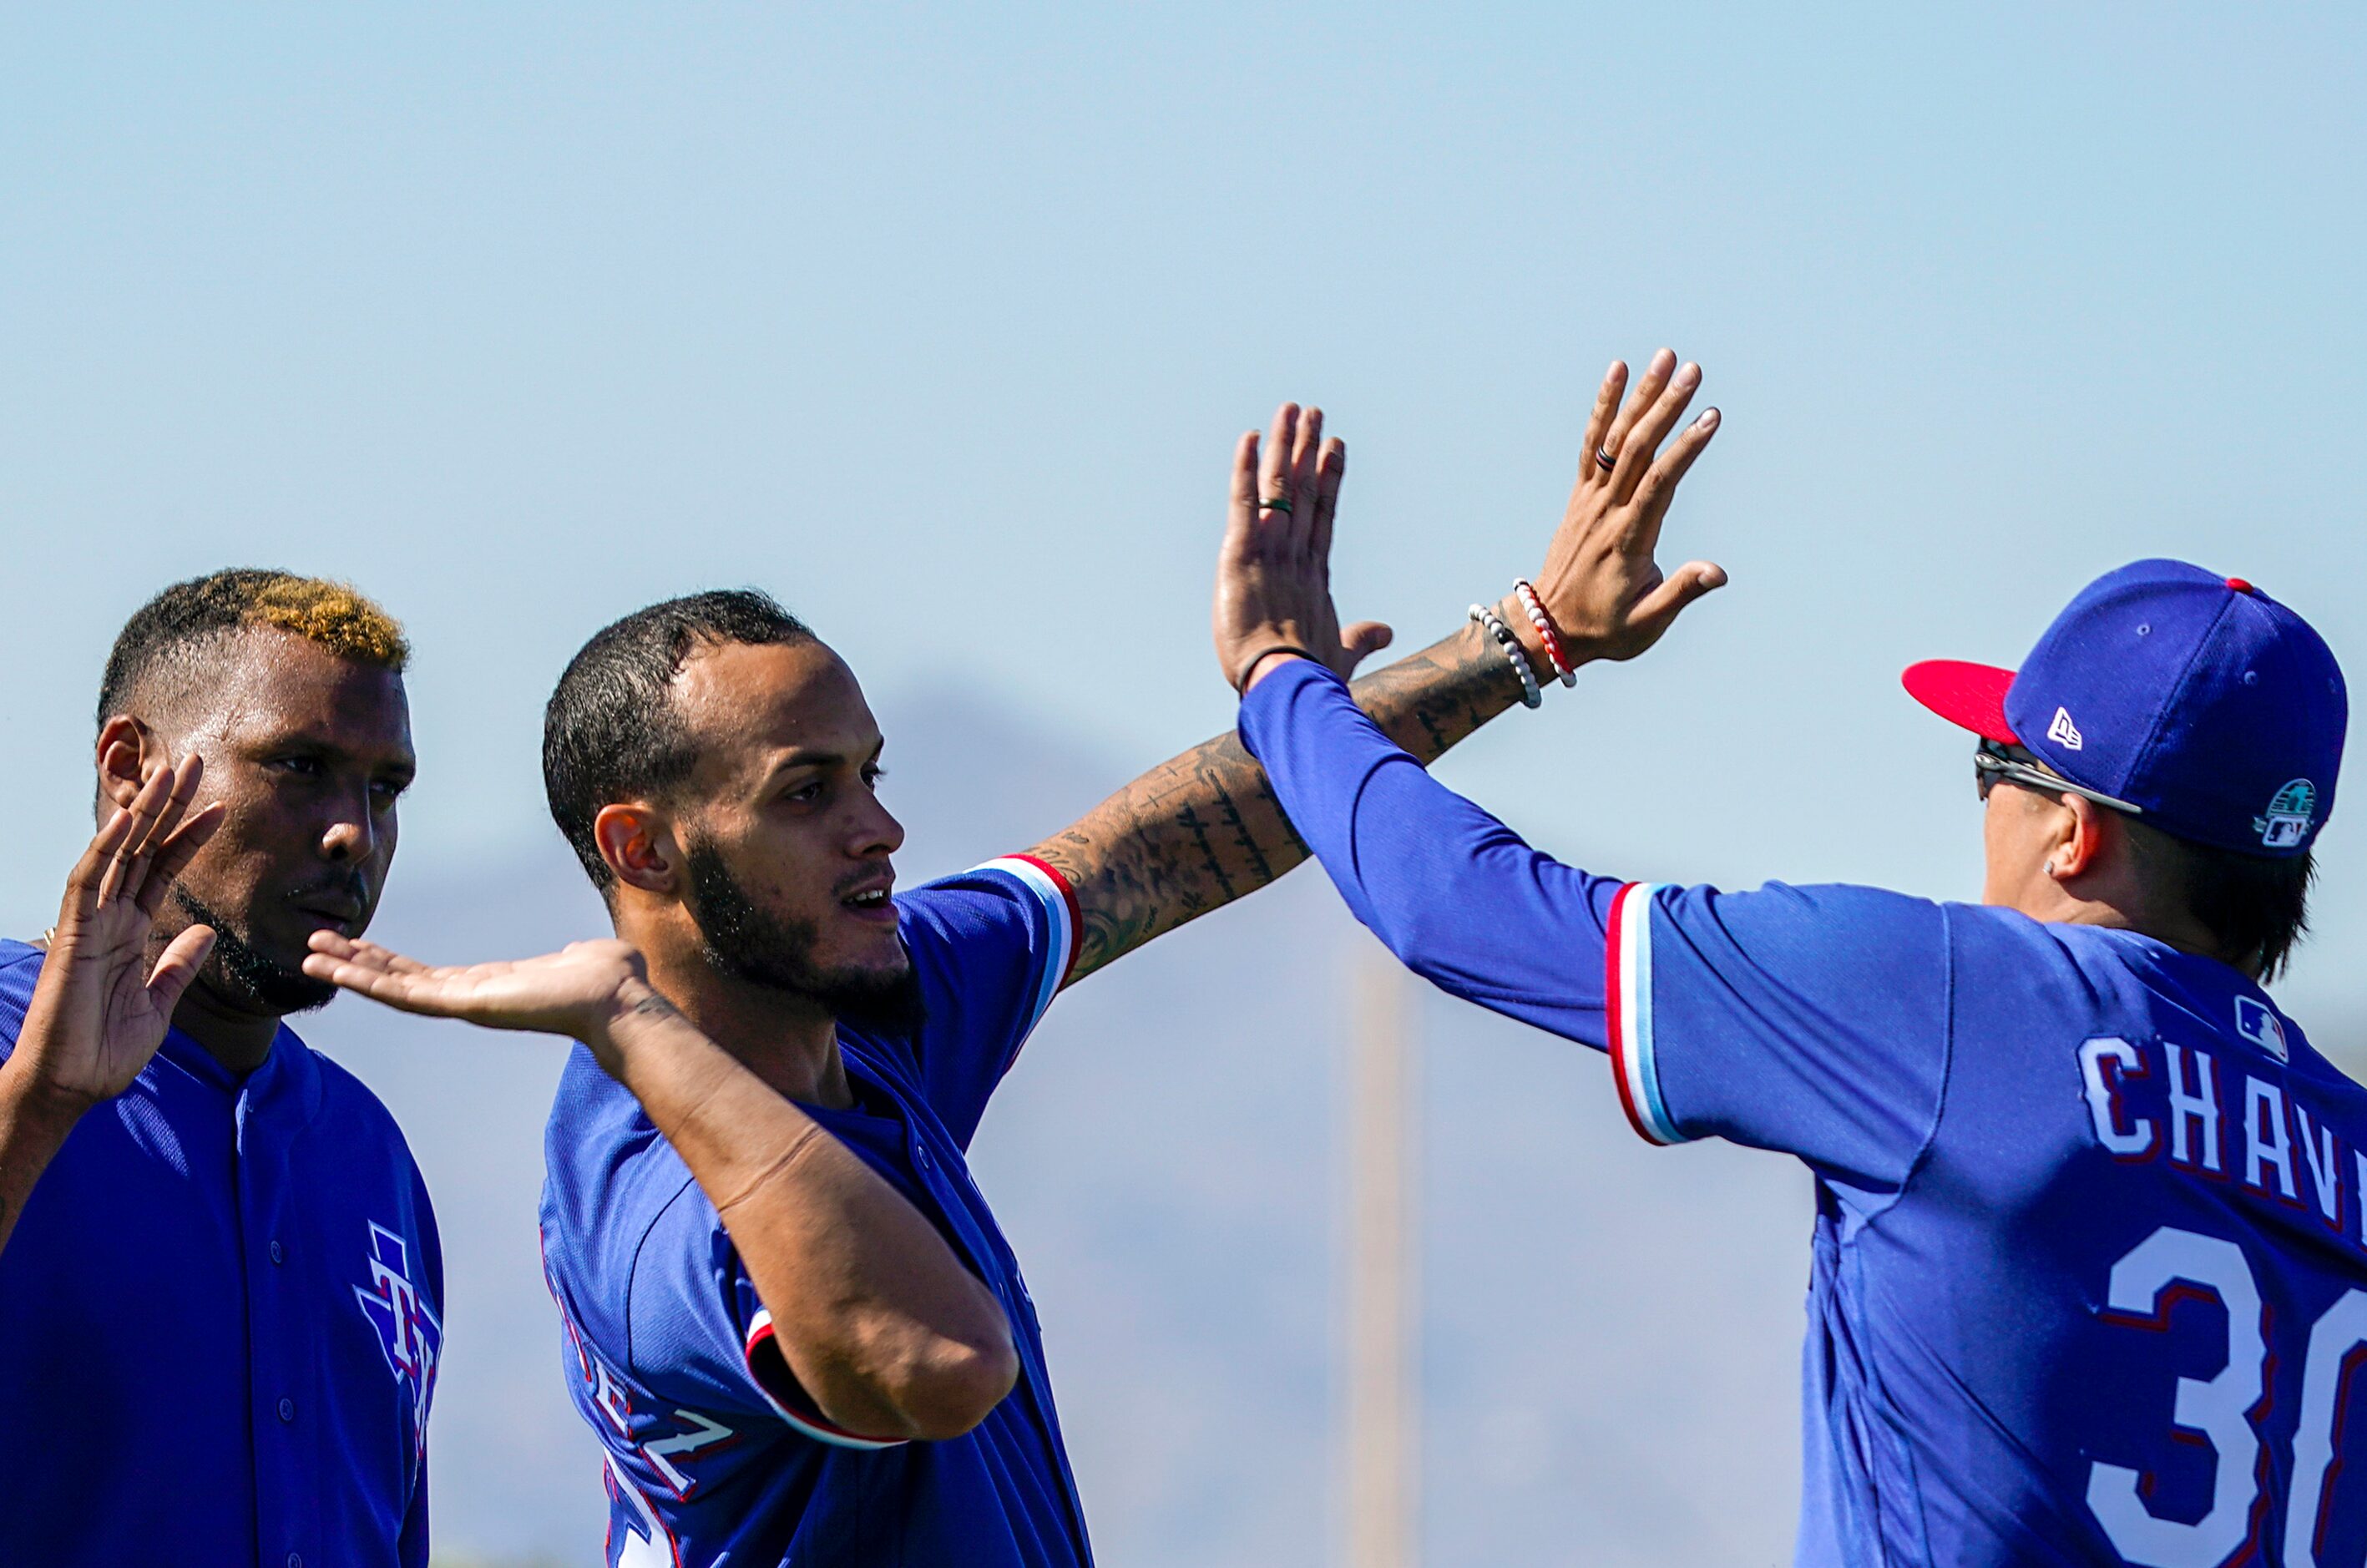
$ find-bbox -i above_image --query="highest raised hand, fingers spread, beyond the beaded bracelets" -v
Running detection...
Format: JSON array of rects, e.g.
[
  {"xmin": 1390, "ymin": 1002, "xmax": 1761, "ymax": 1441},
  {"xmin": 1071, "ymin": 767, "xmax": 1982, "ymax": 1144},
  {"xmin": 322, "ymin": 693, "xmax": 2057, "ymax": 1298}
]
[{"xmin": 1505, "ymin": 348, "xmax": 1726, "ymax": 663}]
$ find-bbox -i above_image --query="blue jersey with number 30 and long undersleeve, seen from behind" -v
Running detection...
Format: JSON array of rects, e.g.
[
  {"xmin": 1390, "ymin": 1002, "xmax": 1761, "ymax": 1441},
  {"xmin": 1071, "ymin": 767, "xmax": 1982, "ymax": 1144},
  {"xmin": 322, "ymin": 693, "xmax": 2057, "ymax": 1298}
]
[{"xmin": 1242, "ymin": 663, "xmax": 2367, "ymax": 1568}]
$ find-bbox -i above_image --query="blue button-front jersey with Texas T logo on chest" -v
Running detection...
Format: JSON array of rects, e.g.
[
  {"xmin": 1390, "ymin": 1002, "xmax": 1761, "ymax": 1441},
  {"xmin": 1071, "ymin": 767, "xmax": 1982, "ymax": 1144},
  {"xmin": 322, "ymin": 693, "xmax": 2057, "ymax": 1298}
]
[{"xmin": 0, "ymin": 943, "xmax": 443, "ymax": 1568}]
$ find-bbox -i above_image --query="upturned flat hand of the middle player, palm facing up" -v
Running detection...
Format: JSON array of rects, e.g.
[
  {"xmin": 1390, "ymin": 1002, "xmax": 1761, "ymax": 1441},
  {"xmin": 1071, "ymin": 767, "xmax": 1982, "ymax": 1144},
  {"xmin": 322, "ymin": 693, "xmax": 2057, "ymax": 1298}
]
[{"xmin": 303, "ymin": 931, "xmax": 670, "ymax": 1073}]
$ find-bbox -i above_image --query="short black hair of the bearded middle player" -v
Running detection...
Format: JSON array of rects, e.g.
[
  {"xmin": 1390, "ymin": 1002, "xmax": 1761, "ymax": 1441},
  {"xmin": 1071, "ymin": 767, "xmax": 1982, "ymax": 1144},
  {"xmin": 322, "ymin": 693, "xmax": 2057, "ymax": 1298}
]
[{"xmin": 542, "ymin": 588, "xmax": 814, "ymax": 893}]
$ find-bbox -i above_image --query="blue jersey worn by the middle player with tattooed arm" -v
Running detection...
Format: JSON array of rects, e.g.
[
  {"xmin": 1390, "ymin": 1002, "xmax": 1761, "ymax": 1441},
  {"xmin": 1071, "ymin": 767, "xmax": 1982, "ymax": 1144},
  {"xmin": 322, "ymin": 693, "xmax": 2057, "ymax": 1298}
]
[{"xmin": 542, "ymin": 857, "xmax": 1091, "ymax": 1568}]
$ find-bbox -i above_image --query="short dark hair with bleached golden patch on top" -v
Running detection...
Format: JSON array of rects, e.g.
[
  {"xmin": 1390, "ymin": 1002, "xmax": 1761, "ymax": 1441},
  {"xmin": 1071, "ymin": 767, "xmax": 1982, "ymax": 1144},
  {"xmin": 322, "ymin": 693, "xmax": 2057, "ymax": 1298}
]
[{"xmin": 99, "ymin": 566, "xmax": 412, "ymax": 725}]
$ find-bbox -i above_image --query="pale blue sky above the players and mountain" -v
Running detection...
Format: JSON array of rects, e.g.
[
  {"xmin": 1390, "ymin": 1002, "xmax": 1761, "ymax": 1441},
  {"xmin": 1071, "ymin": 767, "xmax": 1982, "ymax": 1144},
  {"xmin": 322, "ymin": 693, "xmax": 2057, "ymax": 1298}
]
[{"xmin": 0, "ymin": 5, "xmax": 2367, "ymax": 1563}]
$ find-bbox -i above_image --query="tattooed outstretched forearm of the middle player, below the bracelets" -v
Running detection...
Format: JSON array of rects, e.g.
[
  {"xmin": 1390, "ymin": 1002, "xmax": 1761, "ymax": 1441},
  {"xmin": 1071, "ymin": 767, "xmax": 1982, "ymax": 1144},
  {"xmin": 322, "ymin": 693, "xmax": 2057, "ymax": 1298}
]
[{"xmin": 1029, "ymin": 625, "xmax": 1520, "ymax": 980}]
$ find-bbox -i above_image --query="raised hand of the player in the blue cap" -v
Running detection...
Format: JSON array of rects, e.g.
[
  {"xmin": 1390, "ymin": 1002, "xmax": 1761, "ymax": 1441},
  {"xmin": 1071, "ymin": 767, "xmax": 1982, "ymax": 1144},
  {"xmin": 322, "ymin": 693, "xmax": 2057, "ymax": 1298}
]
[{"xmin": 1214, "ymin": 402, "xmax": 1392, "ymax": 691}]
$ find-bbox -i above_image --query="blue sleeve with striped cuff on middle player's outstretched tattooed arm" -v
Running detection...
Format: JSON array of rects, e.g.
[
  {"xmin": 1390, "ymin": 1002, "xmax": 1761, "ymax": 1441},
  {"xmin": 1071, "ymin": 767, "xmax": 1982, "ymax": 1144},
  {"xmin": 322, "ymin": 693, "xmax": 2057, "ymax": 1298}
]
[{"xmin": 897, "ymin": 855, "xmax": 1077, "ymax": 1149}]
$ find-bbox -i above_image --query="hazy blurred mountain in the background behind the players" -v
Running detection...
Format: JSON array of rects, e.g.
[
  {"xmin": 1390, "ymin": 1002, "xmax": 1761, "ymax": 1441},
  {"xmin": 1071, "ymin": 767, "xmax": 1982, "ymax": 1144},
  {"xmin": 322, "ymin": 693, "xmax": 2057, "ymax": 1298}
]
[{"xmin": 319, "ymin": 691, "xmax": 1808, "ymax": 1568}]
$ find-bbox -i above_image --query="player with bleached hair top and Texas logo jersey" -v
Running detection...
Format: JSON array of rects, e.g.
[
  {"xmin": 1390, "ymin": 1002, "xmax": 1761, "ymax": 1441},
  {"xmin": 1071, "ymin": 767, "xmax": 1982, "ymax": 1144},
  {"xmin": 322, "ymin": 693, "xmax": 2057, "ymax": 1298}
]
[{"xmin": 0, "ymin": 571, "xmax": 443, "ymax": 1568}]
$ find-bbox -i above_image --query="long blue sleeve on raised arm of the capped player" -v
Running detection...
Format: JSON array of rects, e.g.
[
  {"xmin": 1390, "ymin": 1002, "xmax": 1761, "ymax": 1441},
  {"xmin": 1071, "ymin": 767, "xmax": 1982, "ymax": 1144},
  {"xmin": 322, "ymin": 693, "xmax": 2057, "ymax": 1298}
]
[{"xmin": 1241, "ymin": 660, "xmax": 1948, "ymax": 1189}]
